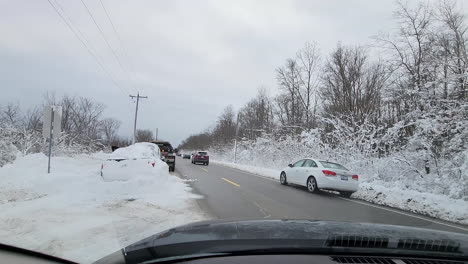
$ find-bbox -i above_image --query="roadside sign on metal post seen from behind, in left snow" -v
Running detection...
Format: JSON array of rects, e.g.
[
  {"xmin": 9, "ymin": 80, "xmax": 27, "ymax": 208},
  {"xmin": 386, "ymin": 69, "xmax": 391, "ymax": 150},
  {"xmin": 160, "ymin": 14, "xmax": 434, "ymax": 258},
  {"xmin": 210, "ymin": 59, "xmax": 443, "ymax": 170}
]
[{"xmin": 42, "ymin": 105, "xmax": 62, "ymax": 173}]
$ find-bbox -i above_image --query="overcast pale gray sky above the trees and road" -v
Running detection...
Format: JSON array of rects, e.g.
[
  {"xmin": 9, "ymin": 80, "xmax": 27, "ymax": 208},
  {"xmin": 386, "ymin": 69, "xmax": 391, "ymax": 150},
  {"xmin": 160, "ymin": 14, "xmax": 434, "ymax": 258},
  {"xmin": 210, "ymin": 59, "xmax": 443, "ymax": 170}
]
[{"xmin": 0, "ymin": 0, "xmax": 396, "ymax": 145}]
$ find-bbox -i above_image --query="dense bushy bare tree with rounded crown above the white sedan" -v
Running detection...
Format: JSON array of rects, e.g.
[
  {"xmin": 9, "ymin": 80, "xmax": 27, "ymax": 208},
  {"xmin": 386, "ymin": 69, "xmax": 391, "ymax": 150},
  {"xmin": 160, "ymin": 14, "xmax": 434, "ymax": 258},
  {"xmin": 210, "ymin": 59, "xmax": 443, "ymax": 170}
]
[{"xmin": 320, "ymin": 45, "xmax": 386, "ymax": 126}]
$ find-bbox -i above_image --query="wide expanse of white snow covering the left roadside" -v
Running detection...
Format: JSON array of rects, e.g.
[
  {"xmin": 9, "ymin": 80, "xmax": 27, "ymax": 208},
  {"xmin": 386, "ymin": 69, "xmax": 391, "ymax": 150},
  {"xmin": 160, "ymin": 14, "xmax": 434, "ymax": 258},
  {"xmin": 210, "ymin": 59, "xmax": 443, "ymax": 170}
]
[{"xmin": 0, "ymin": 144, "xmax": 205, "ymax": 263}]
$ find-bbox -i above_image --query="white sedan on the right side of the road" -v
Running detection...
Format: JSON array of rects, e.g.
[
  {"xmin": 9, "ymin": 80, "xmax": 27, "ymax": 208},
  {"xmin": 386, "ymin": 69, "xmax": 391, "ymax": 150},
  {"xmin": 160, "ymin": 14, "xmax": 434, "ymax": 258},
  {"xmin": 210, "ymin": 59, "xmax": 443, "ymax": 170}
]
[{"xmin": 280, "ymin": 159, "xmax": 359, "ymax": 197}]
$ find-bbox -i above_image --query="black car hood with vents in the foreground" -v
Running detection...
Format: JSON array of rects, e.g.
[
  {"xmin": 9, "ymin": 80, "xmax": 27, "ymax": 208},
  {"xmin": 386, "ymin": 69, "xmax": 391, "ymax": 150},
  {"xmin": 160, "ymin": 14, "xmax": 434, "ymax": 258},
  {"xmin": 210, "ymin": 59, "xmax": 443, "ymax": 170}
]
[{"xmin": 94, "ymin": 220, "xmax": 468, "ymax": 263}]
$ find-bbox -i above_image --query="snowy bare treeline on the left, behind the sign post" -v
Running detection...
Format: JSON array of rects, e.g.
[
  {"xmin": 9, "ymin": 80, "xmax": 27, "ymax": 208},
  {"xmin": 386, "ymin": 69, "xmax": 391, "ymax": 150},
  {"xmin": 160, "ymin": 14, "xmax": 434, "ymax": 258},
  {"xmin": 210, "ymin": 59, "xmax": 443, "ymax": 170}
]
[{"xmin": 0, "ymin": 94, "xmax": 131, "ymax": 166}]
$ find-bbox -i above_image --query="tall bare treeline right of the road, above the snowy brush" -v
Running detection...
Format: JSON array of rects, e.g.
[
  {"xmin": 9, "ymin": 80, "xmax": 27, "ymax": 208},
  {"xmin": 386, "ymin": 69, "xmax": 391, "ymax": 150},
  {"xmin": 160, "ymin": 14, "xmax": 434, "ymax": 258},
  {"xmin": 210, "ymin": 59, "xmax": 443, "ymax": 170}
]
[{"xmin": 179, "ymin": 1, "xmax": 468, "ymax": 163}]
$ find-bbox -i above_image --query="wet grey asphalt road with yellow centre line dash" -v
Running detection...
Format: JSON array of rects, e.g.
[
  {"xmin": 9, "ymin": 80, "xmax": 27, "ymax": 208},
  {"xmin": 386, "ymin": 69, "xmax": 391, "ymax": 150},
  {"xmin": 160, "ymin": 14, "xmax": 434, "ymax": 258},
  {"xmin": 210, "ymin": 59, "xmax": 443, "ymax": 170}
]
[{"xmin": 176, "ymin": 157, "xmax": 468, "ymax": 234}]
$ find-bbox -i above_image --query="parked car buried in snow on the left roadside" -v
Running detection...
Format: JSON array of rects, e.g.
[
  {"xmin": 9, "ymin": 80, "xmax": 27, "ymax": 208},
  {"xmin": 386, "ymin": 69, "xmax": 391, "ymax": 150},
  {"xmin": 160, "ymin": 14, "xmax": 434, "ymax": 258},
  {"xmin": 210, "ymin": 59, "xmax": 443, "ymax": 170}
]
[{"xmin": 101, "ymin": 142, "xmax": 161, "ymax": 180}]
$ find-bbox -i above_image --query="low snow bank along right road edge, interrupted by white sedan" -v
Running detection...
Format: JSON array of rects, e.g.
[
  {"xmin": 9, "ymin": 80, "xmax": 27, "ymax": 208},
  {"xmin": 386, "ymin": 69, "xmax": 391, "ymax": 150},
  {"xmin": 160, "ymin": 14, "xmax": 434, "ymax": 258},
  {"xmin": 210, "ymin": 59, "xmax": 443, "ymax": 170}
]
[{"xmin": 210, "ymin": 160, "xmax": 468, "ymax": 224}]
